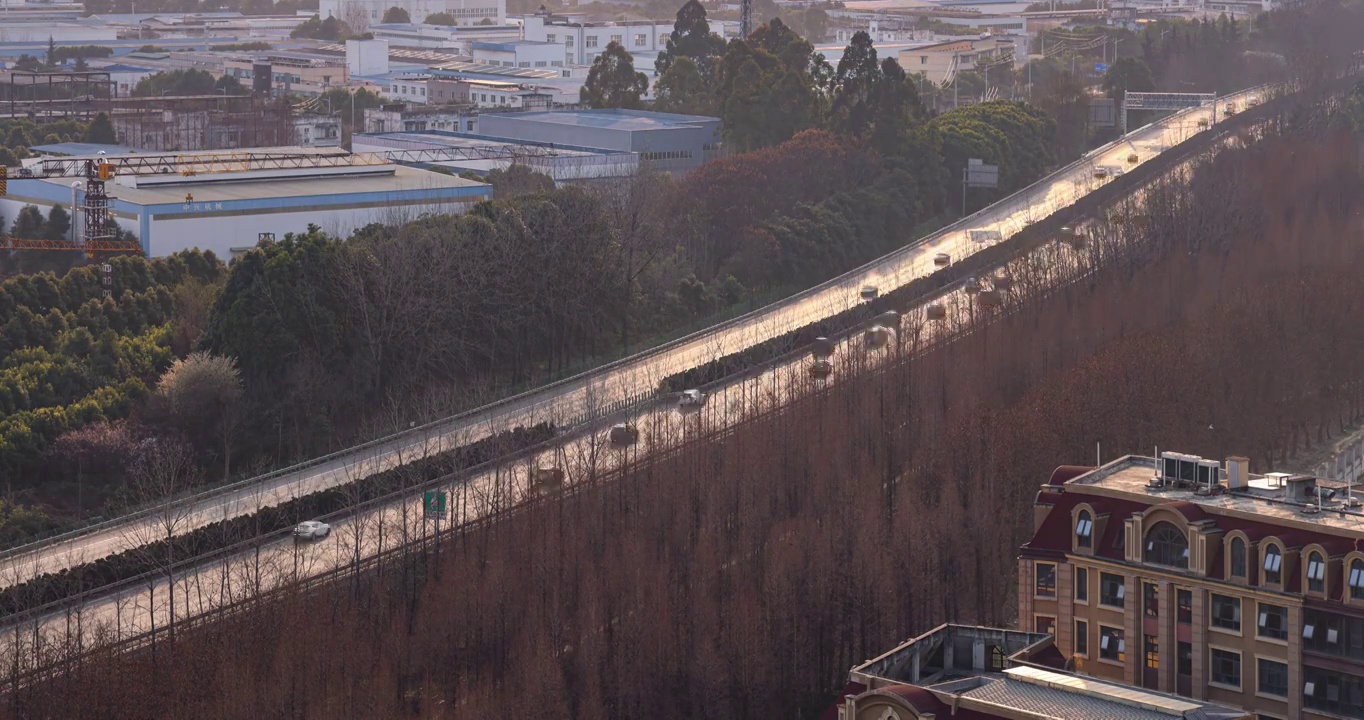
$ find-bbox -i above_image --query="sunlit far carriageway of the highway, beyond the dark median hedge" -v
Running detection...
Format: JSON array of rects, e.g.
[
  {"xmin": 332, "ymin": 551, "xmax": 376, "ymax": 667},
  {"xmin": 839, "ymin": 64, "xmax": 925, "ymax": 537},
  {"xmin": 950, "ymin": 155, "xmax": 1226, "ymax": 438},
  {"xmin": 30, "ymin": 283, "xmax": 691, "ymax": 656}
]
[{"xmin": 0, "ymin": 91, "xmax": 1258, "ymax": 602}]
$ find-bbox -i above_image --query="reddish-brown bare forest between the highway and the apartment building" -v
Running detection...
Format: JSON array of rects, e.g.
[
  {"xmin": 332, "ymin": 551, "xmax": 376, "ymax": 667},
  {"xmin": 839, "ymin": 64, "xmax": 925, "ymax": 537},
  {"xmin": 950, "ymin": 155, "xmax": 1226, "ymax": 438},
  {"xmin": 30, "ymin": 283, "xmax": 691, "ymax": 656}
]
[{"xmin": 8, "ymin": 100, "xmax": 1364, "ymax": 719}]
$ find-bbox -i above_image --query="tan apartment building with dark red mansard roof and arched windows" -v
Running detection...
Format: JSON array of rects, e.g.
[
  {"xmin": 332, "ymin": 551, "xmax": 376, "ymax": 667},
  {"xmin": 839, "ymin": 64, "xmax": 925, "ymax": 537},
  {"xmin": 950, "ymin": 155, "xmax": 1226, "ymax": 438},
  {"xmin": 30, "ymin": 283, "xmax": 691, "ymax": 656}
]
[{"xmin": 1019, "ymin": 453, "xmax": 1364, "ymax": 719}]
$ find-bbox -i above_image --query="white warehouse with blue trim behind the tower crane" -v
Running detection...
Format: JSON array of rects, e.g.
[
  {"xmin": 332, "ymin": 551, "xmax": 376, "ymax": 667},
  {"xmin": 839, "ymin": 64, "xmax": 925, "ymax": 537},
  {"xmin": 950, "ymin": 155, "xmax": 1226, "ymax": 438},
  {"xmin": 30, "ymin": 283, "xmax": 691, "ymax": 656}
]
[{"xmin": 0, "ymin": 147, "xmax": 492, "ymax": 259}]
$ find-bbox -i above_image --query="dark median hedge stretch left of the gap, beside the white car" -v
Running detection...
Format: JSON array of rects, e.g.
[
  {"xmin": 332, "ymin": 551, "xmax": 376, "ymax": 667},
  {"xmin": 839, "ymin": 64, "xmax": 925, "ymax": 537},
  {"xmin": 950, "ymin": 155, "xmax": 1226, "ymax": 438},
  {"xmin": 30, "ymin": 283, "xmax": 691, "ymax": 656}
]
[{"xmin": 0, "ymin": 423, "xmax": 558, "ymax": 616}]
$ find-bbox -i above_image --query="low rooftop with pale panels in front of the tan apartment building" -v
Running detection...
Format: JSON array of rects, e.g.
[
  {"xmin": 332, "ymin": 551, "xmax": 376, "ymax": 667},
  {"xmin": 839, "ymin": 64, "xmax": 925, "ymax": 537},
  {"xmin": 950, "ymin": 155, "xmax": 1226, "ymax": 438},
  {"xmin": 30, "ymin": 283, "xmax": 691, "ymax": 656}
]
[{"xmin": 824, "ymin": 625, "xmax": 1251, "ymax": 720}]
